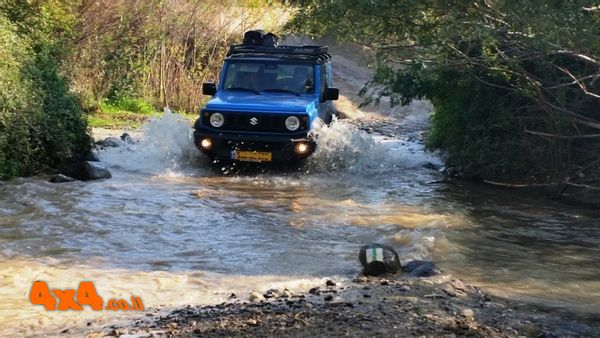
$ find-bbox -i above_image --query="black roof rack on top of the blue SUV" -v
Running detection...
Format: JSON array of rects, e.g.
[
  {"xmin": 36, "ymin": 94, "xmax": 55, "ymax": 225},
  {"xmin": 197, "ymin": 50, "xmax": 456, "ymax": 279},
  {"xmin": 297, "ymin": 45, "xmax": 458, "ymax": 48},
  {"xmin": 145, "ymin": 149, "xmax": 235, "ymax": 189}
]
[{"xmin": 227, "ymin": 45, "xmax": 331, "ymax": 61}]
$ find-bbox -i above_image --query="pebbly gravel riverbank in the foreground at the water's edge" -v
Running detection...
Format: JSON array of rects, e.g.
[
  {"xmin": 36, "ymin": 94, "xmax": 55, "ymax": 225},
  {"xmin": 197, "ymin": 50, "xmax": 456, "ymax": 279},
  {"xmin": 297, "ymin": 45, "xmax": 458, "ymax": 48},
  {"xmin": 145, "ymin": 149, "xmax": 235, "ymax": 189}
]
[{"xmin": 87, "ymin": 276, "xmax": 600, "ymax": 337}]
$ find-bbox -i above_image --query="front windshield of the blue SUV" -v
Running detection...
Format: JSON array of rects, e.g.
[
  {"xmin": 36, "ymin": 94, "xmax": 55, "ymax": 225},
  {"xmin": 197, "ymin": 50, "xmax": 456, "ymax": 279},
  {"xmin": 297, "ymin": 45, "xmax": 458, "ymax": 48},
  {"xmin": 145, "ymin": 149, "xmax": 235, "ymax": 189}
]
[{"xmin": 223, "ymin": 61, "xmax": 315, "ymax": 95}]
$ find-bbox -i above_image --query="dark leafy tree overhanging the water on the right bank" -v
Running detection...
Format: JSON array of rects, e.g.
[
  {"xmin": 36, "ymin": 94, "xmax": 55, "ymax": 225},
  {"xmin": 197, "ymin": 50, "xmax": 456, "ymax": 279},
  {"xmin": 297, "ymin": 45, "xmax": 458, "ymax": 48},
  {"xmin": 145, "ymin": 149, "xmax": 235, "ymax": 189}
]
[{"xmin": 289, "ymin": 0, "xmax": 600, "ymax": 185}]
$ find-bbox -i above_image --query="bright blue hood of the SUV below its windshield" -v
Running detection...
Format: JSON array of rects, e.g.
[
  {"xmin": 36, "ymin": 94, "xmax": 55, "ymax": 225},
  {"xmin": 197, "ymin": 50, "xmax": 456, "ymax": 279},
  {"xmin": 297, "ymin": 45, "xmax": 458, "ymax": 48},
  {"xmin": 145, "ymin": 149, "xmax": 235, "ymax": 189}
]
[{"xmin": 206, "ymin": 92, "xmax": 318, "ymax": 112}]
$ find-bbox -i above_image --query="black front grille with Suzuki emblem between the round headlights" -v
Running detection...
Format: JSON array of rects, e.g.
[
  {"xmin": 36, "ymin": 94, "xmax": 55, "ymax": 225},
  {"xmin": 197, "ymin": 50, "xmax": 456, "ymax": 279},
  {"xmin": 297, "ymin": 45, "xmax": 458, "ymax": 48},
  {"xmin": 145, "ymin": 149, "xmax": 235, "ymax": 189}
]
[{"xmin": 204, "ymin": 112, "xmax": 308, "ymax": 133}]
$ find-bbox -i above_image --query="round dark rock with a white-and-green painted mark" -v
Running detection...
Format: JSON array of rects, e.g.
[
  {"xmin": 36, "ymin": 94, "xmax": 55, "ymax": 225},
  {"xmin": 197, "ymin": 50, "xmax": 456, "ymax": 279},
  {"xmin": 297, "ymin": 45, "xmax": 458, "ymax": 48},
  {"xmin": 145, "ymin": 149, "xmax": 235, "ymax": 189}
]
[{"xmin": 358, "ymin": 243, "xmax": 401, "ymax": 276}]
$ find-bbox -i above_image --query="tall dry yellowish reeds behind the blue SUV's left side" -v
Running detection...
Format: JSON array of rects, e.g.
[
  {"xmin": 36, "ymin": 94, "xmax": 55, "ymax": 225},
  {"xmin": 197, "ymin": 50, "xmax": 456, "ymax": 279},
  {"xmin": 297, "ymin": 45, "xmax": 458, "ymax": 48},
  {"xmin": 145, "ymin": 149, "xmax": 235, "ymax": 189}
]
[{"xmin": 70, "ymin": 0, "xmax": 285, "ymax": 112}]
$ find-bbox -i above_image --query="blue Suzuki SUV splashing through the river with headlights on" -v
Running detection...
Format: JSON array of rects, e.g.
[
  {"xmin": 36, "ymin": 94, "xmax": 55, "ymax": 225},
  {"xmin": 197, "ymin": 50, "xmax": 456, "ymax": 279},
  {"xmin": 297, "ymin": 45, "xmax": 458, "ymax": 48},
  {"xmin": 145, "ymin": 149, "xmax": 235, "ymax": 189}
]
[{"xmin": 194, "ymin": 31, "xmax": 339, "ymax": 162}]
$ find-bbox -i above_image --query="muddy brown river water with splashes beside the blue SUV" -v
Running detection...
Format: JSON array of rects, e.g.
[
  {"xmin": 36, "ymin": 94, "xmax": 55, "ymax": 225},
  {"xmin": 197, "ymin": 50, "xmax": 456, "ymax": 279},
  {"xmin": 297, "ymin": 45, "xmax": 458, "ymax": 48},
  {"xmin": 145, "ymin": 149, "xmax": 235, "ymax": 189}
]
[{"xmin": 0, "ymin": 109, "xmax": 600, "ymax": 334}]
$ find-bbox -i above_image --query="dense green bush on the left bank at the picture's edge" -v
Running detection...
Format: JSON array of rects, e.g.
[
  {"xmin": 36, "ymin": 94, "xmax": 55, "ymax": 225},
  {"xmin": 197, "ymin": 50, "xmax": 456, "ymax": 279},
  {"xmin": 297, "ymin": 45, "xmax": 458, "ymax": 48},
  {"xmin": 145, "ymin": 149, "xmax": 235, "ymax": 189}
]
[{"xmin": 0, "ymin": 0, "xmax": 90, "ymax": 178}]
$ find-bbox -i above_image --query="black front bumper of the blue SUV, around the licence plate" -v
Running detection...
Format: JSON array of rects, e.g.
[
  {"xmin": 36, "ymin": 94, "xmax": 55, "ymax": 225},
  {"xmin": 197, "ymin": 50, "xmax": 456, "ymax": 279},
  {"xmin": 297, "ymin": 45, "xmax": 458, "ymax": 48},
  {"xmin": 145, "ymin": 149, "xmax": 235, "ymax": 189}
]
[{"xmin": 194, "ymin": 125, "xmax": 316, "ymax": 162}]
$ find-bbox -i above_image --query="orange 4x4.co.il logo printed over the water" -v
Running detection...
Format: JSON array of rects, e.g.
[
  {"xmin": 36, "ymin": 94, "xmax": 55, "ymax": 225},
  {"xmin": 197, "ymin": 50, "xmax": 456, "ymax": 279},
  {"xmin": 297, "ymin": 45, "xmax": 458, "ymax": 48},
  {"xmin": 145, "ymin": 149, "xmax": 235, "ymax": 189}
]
[{"xmin": 29, "ymin": 281, "xmax": 144, "ymax": 311}]
